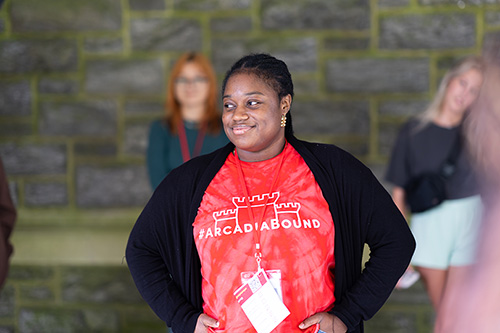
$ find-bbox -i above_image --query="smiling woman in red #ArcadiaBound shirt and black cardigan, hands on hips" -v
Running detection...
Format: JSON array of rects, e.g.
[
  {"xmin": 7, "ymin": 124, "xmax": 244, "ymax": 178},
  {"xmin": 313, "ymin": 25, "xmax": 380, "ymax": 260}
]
[{"xmin": 127, "ymin": 54, "xmax": 415, "ymax": 333}]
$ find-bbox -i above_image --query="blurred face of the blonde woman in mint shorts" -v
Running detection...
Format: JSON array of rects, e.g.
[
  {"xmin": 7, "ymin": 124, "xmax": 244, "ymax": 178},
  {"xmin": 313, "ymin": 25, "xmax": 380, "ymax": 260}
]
[{"xmin": 443, "ymin": 69, "xmax": 483, "ymax": 115}]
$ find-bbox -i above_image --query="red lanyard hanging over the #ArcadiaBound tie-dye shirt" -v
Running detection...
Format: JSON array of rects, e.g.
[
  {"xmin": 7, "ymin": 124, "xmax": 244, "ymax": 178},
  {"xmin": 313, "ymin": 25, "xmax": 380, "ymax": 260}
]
[{"xmin": 235, "ymin": 143, "xmax": 287, "ymax": 269}]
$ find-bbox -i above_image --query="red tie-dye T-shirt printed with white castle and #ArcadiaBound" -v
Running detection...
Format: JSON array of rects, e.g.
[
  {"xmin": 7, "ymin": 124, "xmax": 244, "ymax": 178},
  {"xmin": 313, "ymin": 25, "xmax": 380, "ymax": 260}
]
[{"xmin": 193, "ymin": 145, "xmax": 335, "ymax": 333}]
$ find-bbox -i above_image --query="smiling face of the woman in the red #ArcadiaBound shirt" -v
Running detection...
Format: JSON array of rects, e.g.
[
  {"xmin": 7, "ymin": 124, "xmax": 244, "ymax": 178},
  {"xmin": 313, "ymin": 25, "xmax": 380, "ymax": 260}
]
[{"xmin": 222, "ymin": 73, "xmax": 292, "ymax": 162}]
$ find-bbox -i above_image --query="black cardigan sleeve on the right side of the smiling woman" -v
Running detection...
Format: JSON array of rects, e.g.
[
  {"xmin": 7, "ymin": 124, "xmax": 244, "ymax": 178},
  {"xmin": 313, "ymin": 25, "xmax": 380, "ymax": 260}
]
[{"xmin": 332, "ymin": 153, "xmax": 415, "ymax": 330}]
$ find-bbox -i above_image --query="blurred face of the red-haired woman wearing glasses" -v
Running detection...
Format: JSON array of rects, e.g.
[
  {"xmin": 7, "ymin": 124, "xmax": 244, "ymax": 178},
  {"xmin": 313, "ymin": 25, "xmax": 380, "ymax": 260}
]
[{"xmin": 174, "ymin": 62, "xmax": 209, "ymax": 107}]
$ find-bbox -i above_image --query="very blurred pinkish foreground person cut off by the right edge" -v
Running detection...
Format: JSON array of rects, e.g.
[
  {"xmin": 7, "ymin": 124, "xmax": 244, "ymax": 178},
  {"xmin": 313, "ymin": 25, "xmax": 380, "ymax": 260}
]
[{"xmin": 435, "ymin": 62, "xmax": 500, "ymax": 333}]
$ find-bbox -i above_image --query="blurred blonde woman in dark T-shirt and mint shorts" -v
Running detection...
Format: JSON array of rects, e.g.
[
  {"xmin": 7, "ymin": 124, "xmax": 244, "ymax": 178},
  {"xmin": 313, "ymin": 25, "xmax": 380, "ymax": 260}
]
[{"xmin": 386, "ymin": 57, "xmax": 484, "ymax": 310}]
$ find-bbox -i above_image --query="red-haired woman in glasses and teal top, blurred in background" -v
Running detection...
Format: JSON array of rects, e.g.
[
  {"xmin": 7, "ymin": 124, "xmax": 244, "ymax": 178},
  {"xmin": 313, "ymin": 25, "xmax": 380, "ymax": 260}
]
[{"xmin": 147, "ymin": 53, "xmax": 229, "ymax": 189}]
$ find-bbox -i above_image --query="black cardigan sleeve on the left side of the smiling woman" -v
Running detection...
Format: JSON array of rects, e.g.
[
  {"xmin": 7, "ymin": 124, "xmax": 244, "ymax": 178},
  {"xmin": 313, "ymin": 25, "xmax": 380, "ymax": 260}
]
[{"xmin": 126, "ymin": 184, "xmax": 202, "ymax": 333}]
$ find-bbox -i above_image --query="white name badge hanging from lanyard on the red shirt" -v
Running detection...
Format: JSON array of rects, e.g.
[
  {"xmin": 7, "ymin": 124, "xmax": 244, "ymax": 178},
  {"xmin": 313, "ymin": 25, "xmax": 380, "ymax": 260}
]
[{"xmin": 234, "ymin": 269, "xmax": 290, "ymax": 333}]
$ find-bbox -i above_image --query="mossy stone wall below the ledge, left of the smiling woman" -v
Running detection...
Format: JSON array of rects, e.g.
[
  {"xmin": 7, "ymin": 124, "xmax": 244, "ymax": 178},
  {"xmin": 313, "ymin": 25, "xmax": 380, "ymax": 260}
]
[{"xmin": 0, "ymin": 265, "xmax": 165, "ymax": 333}]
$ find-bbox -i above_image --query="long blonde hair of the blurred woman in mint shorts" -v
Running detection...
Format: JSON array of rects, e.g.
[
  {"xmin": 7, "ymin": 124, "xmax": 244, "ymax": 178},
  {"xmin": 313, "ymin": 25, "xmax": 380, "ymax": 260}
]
[{"xmin": 417, "ymin": 56, "xmax": 484, "ymax": 129}]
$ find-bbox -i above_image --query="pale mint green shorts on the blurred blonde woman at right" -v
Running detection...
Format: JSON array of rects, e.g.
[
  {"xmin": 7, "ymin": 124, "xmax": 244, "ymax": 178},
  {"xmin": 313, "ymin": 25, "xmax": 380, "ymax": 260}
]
[{"xmin": 411, "ymin": 195, "xmax": 483, "ymax": 269}]
